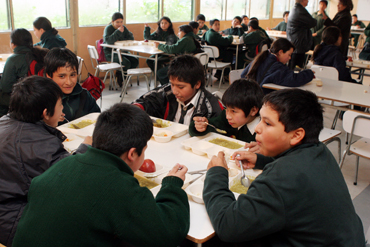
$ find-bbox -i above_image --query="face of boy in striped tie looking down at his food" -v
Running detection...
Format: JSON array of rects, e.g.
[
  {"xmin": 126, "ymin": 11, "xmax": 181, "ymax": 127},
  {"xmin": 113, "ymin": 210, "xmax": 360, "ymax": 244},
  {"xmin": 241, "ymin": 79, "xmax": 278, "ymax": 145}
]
[{"xmin": 170, "ymin": 76, "xmax": 201, "ymax": 105}]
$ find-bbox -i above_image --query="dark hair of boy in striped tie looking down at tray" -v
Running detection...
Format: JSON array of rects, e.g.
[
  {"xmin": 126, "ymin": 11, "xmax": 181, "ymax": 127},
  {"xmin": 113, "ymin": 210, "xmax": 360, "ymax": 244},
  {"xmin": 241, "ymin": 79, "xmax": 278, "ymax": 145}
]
[{"xmin": 168, "ymin": 55, "xmax": 205, "ymax": 88}]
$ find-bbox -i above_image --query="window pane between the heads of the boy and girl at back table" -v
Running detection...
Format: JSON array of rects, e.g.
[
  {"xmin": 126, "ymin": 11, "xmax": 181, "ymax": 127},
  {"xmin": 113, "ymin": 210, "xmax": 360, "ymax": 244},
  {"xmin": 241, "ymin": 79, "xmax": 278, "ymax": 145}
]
[{"xmin": 126, "ymin": 0, "xmax": 158, "ymax": 23}]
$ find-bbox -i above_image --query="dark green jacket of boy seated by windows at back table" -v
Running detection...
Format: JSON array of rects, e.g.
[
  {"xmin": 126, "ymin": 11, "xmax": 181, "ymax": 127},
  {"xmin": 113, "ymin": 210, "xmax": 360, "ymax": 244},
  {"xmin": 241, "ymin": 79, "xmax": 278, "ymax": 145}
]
[{"xmin": 103, "ymin": 24, "xmax": 134, "ymax": 58}]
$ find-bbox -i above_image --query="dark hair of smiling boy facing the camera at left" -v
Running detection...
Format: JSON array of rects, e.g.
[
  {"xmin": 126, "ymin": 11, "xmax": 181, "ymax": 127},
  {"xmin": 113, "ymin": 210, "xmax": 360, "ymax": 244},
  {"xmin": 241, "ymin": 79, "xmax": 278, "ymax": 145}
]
[{"xmin": 44, "ymin": 48, "xmax": 78, "ymax": 77}]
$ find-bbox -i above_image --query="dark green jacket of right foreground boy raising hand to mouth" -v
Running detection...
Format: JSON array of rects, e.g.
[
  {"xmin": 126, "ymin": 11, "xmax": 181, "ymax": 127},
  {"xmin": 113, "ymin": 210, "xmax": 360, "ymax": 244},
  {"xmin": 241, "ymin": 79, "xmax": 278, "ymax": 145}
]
[{"xmin": 203, "ymin": 143, "xmax": 365, "ymax": 247}]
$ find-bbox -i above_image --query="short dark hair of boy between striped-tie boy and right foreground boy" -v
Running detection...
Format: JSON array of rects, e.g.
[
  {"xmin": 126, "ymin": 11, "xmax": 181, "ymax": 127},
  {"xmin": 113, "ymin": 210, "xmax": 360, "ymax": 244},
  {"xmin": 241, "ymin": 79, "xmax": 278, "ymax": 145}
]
[{"xmin": 222, "ymin": 79, "xmax": 263, "ymax": 117}]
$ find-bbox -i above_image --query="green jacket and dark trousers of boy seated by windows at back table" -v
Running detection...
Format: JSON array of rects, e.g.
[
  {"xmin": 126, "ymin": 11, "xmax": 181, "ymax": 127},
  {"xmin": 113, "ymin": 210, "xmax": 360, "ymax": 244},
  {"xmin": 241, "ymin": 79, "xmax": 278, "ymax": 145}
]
[{"xmin": 103, "ymin": 24, "xmax": 139, "ymax": 71}]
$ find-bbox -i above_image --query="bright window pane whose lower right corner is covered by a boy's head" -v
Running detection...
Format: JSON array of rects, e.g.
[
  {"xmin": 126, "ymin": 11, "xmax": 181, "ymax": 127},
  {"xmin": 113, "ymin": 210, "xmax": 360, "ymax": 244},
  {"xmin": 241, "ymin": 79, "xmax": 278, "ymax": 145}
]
[{"xmin": 78, "ymin": 0, "xmax": 122, "ymax": 26}]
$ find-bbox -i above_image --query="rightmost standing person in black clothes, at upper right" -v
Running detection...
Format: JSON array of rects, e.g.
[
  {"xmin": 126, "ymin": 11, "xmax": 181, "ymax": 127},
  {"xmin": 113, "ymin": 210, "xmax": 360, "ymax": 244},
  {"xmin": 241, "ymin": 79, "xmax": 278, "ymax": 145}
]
[{"xmin": 323, "ymin": 0, "xmax": 353, "ymax": 60}]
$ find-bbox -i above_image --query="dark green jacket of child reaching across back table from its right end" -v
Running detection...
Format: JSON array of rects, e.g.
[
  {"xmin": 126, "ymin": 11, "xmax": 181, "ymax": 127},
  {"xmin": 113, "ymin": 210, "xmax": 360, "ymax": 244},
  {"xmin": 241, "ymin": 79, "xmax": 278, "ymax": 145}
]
[{"xmin": 158, "ymin": 32, "xmax": 197, "ymax": 54}]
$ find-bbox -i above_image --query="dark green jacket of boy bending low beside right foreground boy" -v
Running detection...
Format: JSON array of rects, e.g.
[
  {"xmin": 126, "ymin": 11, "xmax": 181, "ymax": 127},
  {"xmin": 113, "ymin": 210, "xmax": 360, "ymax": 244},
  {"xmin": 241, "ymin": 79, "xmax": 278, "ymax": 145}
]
[{"xmin": 189, "ymin": 110, "xmax": 256, "ymax": 142}]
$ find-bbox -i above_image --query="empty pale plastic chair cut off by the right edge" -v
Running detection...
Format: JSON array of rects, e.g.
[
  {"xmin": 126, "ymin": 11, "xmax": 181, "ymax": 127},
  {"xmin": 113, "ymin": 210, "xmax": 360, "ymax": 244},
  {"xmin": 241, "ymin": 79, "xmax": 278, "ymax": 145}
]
[{"xmin": 339, "ymin": 110, "xmax": 370, "ymax": 185}]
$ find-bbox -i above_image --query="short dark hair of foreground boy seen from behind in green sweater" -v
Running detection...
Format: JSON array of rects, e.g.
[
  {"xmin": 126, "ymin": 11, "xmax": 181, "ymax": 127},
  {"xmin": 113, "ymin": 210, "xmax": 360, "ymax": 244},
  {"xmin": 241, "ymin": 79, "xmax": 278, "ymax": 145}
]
[{"xmin": 92, "ymin": 103, "xmax": 153, "ymax": 157}]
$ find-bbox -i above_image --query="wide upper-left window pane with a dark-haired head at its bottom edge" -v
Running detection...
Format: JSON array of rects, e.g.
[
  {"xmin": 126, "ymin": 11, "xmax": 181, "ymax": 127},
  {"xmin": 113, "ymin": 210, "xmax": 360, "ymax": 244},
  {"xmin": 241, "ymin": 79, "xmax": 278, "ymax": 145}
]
[{"xmin": 12, "ymin": 0, "xmax": 69, "ymax": 29}]
